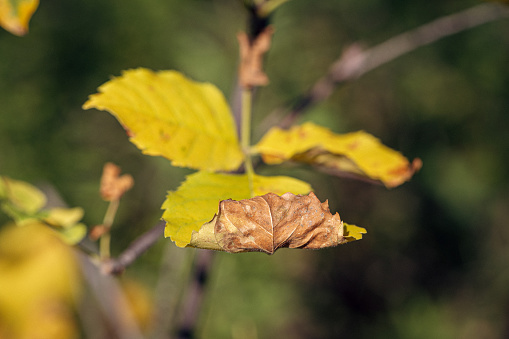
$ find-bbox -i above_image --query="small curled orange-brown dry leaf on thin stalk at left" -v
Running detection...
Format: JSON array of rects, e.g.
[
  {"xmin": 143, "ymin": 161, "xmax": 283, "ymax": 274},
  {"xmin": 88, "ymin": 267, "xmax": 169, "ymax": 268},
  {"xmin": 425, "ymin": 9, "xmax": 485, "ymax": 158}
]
[{"xmin": 100, "ymin": 162, "xmax": 134, "ymax": 201}]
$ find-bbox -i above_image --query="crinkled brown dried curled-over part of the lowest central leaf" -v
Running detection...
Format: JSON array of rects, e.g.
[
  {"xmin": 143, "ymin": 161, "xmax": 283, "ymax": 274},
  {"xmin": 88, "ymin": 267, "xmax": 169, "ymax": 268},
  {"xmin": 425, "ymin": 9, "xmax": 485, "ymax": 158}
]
[{"xmin": 191, "ymin": 192, "xmax": 366, "ymax": 254}]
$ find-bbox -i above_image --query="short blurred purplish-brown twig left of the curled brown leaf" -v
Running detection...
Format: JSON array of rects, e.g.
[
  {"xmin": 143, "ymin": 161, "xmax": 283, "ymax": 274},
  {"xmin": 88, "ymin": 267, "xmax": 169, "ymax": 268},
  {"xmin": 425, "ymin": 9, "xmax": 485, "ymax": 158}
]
[{"xmin": 101, "ymin": 221, "xmax": 165, "ymax": 274}]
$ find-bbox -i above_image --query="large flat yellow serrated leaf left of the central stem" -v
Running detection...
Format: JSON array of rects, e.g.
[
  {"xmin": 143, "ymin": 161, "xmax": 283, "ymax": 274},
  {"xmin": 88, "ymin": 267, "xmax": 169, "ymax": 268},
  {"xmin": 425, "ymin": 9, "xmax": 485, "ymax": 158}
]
[{"xmin": 83, "ymin": 68, "xmax": 244, "ymax": 171}]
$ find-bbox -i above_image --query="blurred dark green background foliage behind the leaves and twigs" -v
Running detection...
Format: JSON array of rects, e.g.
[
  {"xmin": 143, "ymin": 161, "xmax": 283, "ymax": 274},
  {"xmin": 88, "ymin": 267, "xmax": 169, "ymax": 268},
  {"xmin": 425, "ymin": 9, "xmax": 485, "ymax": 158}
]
[{"xmin": 0, "ymin": 0, "xmax": 509, "ymax": 339}]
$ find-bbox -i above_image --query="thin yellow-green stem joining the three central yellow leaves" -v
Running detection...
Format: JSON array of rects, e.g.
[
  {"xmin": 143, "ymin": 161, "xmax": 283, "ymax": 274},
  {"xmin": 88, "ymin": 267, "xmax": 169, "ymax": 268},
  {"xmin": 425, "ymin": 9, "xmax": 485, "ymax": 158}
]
[{"xmin": 240, "ymin": 88, "xmax": 254, "ymax": 197}]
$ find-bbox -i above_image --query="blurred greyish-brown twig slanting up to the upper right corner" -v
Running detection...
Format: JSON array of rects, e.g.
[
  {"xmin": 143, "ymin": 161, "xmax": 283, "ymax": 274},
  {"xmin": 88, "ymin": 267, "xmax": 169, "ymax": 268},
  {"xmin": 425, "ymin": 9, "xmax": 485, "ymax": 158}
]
[{"xmin": 272, "ymin": 4, "xmax": 509, "ymax": 128}]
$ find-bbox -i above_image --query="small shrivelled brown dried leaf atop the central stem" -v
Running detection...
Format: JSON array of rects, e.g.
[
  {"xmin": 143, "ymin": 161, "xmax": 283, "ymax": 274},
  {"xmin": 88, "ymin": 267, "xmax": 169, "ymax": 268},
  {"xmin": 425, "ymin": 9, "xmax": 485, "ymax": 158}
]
[{"xmin": 237, "ymin": 26, "xmax": 274, "ymax": 89}]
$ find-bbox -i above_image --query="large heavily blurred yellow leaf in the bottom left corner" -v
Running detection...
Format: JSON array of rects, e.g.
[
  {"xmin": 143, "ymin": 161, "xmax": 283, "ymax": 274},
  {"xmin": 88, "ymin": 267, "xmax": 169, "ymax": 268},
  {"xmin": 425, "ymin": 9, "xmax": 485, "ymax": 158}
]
[{"xmin": 0, "ymin": 222, "xmax": 80, "ymax": 339}]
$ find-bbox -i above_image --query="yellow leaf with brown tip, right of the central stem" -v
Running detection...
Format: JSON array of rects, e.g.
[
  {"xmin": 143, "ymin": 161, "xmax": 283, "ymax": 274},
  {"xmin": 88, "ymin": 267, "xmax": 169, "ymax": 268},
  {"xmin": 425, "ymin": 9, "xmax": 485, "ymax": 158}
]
[{"xmin": 253, "ymin": 123, "xmax": 421, "ymax": 188}]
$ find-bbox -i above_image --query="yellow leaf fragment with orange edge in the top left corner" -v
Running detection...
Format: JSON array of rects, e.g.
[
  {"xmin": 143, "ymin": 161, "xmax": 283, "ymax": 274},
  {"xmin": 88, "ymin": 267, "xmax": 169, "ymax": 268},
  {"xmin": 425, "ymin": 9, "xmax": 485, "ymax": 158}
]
[{"xmin": 0, "ymin": 0, "xmax": 39, "ymax": 36}]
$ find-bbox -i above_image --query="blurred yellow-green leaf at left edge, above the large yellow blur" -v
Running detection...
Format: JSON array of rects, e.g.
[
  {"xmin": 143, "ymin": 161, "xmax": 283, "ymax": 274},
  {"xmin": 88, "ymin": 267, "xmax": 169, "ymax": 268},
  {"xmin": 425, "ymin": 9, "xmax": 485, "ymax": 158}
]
[{"xmin": 0, "ymin": 177, "xmax": 46, "ymax": 222}]
